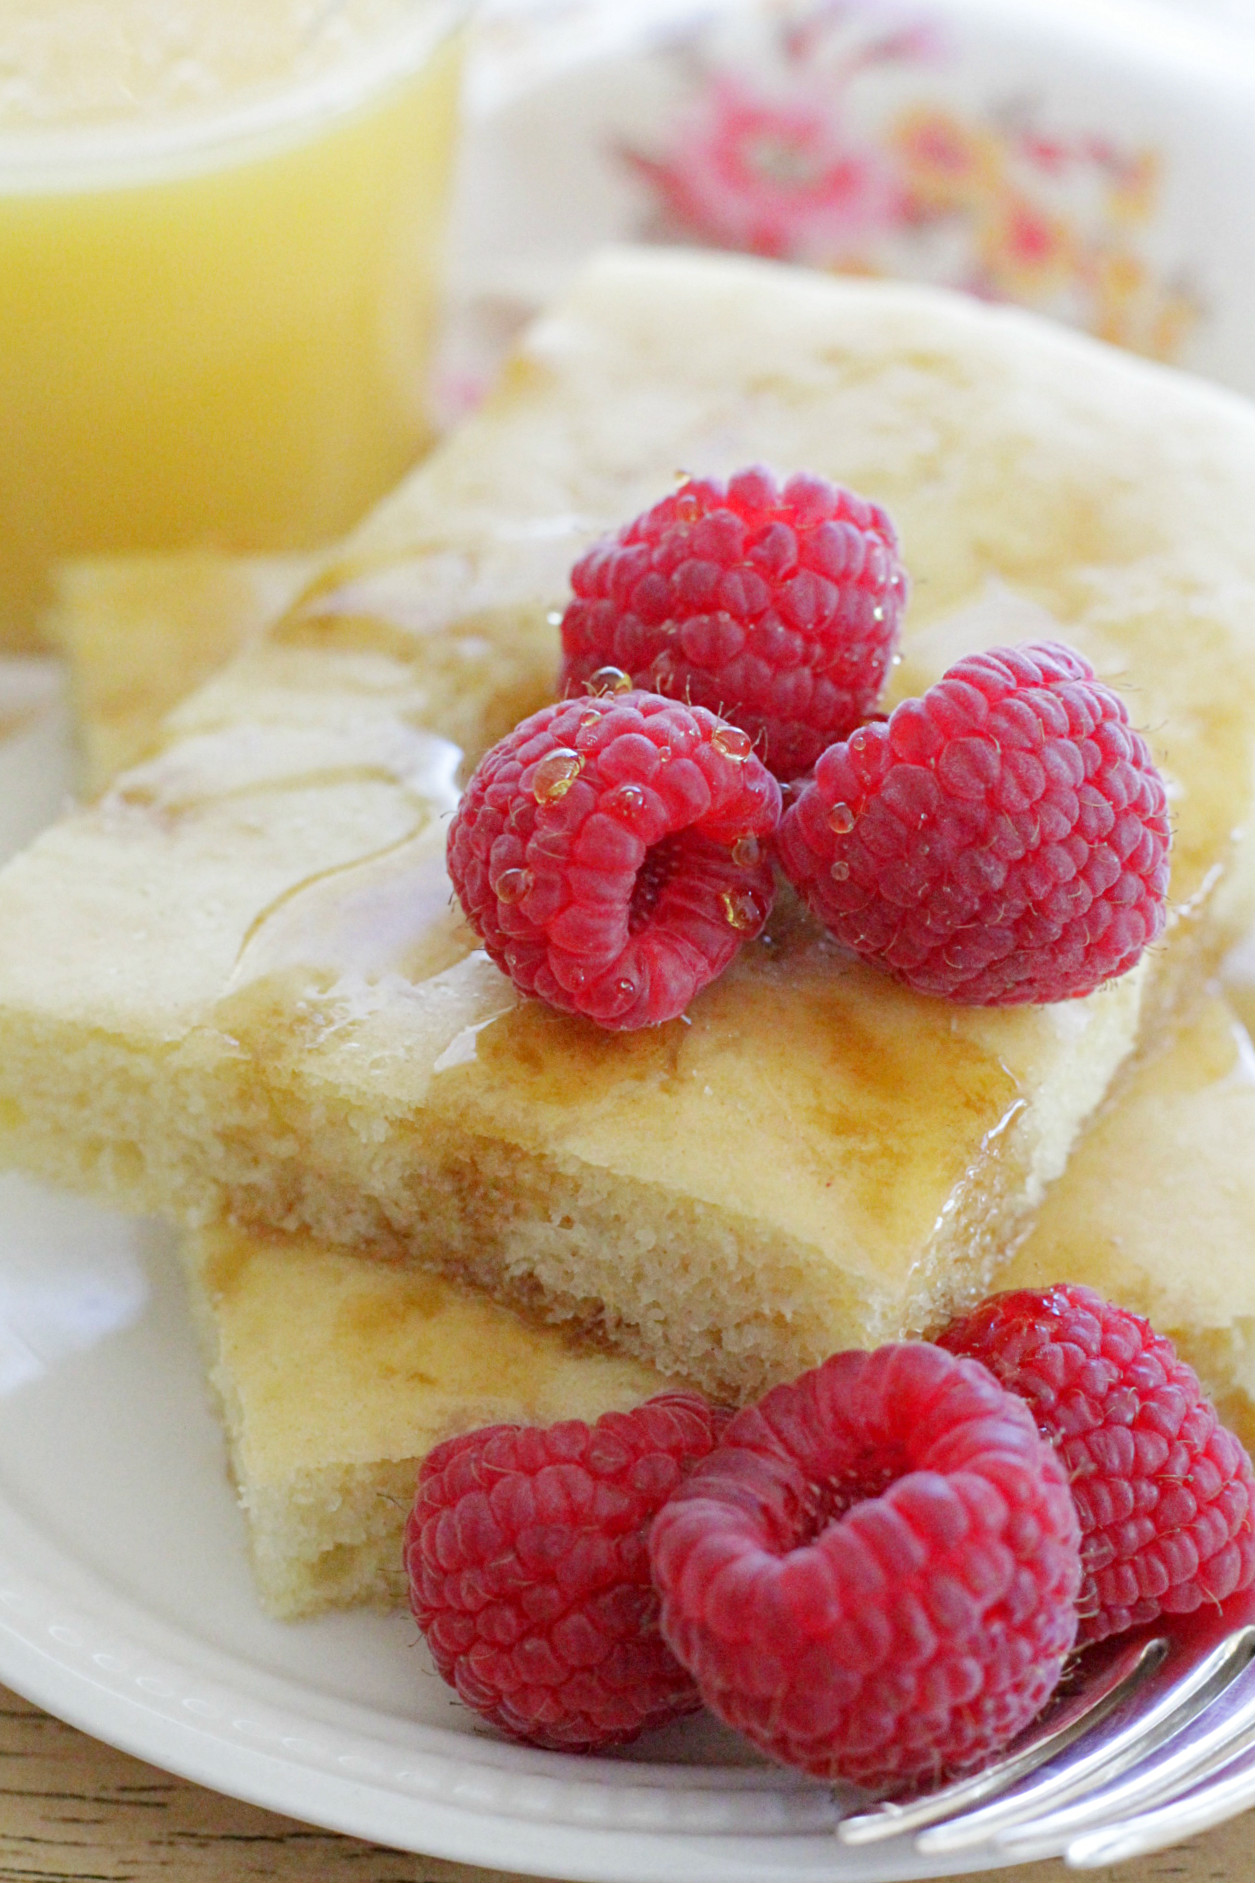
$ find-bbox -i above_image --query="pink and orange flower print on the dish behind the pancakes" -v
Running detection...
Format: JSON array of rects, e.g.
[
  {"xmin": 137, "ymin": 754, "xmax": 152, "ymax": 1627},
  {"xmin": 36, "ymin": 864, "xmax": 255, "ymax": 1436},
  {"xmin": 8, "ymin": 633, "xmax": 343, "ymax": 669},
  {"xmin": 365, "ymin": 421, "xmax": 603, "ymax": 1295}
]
[{"xmin": 620, "ymin": 0, "xmax": 1202, "ymax": 360}]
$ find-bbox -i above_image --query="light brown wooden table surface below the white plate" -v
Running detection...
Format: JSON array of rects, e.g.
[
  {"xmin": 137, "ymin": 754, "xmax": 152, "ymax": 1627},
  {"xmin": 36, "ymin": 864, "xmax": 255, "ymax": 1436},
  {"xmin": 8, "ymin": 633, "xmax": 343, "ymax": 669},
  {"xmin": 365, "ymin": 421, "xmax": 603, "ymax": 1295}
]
[{"xmin": 0, "ymin": 1687, "xmax": 1255, "ymax": 1883}]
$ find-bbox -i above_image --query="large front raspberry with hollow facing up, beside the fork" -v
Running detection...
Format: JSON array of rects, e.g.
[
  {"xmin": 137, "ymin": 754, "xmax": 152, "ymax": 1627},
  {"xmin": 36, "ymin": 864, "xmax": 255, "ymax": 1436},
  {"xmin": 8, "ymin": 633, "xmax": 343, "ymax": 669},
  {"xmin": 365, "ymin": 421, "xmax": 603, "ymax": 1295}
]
[{"xmin": 650, "ymin": 1341, "xmax": 1080, "ymax": 1789}]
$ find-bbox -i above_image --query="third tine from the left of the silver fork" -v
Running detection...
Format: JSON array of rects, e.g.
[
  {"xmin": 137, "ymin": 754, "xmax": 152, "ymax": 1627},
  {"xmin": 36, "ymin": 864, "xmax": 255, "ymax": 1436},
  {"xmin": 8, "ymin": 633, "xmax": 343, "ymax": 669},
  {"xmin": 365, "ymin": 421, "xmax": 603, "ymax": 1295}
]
[{"xmin": 997, "ymin": 1638, "xmax": 1255, "ymax": 1859}]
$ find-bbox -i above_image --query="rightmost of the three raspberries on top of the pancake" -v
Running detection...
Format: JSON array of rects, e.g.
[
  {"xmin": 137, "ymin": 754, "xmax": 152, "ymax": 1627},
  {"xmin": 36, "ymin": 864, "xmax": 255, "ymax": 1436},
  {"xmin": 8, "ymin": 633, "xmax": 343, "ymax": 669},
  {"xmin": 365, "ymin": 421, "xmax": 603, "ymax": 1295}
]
[{"xmin": 778, "ymin": 644, "xmax": 1168, "ymax": 1007}]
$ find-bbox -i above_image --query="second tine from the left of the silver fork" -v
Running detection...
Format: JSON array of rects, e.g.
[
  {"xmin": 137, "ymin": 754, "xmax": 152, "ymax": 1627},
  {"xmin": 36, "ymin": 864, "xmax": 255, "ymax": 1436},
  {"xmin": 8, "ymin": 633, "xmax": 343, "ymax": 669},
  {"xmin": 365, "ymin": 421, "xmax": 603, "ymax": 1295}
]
[{"xmin": 916, "ymin": 1627, "xmax": 1255, "ymax": 1855}]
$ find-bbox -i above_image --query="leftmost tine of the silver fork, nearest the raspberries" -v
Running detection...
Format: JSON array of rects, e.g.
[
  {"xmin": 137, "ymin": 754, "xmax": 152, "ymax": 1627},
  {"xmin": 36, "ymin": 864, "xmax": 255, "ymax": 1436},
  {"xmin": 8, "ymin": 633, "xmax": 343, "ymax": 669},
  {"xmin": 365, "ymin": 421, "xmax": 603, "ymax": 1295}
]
[{"xmin": 837, "ymin": 1636, "xmax": 1168, "ymax": 1845}]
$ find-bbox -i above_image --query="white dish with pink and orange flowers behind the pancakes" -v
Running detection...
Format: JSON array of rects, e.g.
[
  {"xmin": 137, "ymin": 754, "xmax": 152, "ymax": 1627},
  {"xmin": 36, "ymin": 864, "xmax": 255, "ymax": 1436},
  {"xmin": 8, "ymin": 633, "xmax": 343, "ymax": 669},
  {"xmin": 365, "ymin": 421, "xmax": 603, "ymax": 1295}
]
[{"xmin": 439, "ymin": 0, "xmax": 1255, "ymax": 416}]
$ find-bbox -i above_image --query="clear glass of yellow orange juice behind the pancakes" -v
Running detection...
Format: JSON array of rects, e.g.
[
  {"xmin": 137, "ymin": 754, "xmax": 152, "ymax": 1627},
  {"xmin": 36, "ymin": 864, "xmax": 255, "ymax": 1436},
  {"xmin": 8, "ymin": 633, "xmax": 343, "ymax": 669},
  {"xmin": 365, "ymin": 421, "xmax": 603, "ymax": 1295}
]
[{"xmin": 0, "ymin": 0, "xmax": 465, "ymax": 648}]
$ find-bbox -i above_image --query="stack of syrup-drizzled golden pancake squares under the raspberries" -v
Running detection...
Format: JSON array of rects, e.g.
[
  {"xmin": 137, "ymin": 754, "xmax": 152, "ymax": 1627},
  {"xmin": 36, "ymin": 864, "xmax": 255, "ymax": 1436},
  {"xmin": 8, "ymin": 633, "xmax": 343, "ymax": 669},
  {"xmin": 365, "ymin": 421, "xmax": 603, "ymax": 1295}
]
[{"xmin": 0, "ymin": 250, "xmax": 1255, "ymax": 1616}]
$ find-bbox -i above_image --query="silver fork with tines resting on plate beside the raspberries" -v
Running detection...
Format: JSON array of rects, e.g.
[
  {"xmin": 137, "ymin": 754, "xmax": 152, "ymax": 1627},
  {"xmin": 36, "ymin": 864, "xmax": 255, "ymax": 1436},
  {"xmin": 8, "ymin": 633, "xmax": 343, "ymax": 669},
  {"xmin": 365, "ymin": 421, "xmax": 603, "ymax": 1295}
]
[{"xmin": 837, "ymin": 1589, "xmax": 1255, "ymax": 1870}]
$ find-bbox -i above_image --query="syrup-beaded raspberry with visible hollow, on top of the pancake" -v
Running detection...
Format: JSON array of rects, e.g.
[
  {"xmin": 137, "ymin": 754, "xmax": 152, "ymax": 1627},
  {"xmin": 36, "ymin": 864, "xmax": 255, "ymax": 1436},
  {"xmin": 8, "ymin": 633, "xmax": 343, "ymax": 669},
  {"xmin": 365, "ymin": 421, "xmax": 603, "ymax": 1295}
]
[{"xmin": 448, "ymin": 693, "xmax": 780, "ymax": 1028}]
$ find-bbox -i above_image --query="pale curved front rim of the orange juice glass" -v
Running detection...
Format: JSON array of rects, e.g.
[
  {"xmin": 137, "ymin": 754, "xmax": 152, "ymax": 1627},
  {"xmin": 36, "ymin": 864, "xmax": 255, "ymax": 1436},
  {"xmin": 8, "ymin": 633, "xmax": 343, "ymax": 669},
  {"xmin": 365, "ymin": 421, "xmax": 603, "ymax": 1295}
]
[{"xmin": 0, "ymin": 0, "xmax": 475, "ymax": 198}]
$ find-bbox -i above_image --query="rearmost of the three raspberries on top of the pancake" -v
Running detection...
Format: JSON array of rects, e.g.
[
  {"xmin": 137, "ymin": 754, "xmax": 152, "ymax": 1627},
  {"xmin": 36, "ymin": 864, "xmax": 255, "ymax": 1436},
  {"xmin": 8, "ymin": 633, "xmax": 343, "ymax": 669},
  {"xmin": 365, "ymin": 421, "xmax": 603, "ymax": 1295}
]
[{"xmin": 562, "ymin": 467, "xmax": 906, "ymax": 778}]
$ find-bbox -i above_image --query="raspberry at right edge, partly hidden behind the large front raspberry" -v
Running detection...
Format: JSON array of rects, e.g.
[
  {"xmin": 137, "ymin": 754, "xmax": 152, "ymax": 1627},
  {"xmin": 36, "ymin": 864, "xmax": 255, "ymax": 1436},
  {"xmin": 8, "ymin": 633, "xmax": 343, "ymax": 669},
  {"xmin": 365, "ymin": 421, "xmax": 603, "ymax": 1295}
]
[{"xmin": 938, "ymin": 1284, "xmax": 1255, "ymax": 1642}]
